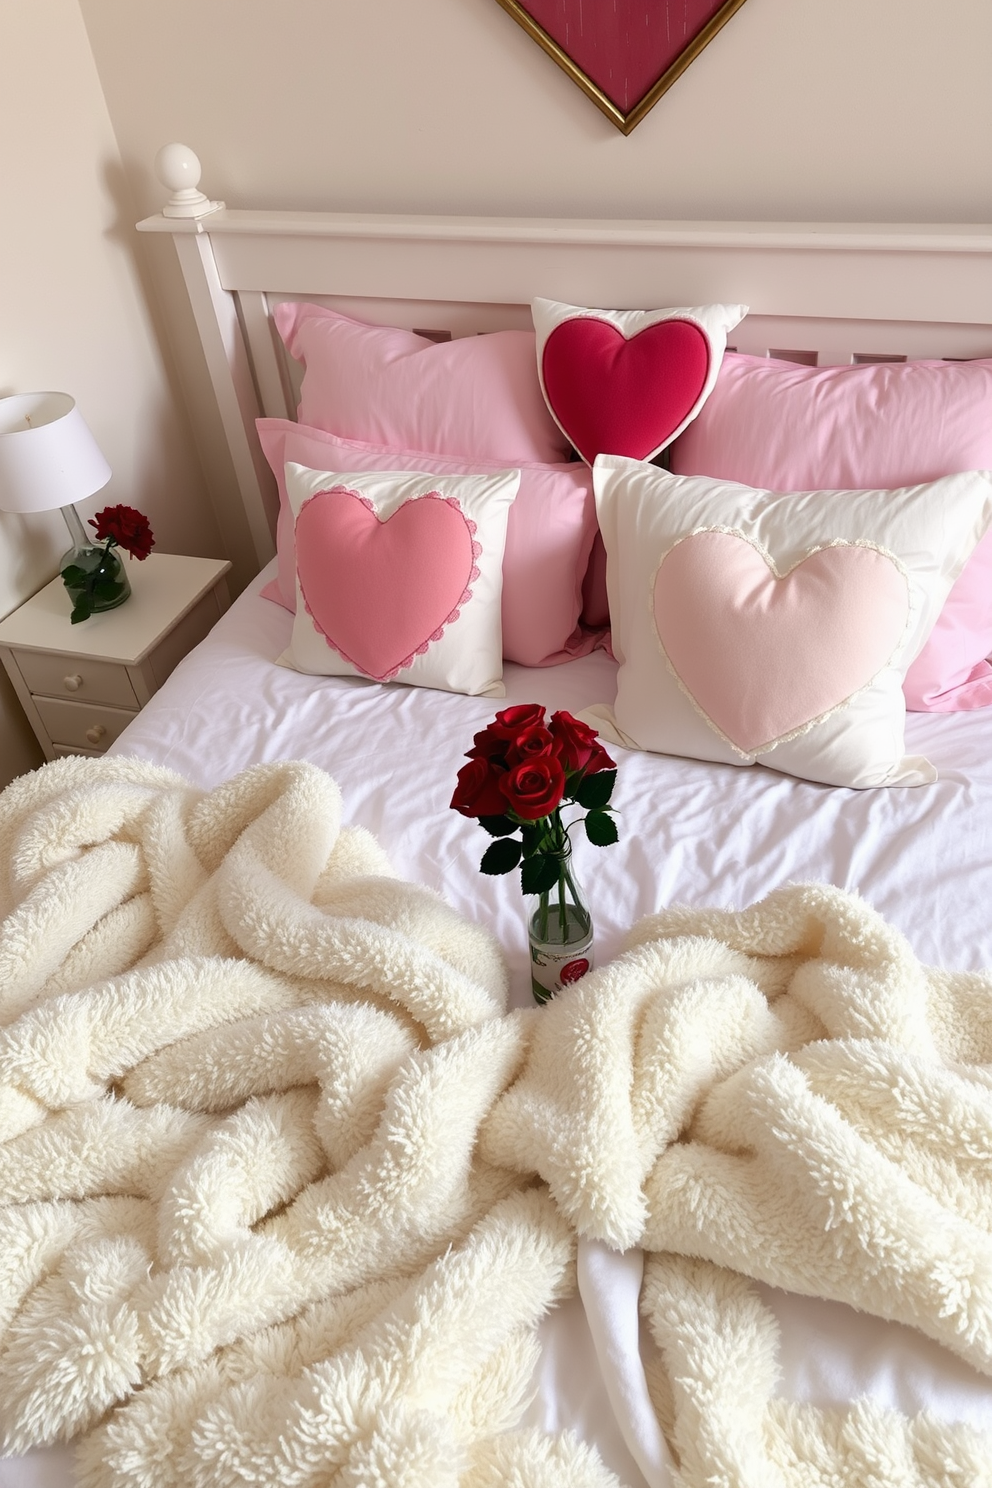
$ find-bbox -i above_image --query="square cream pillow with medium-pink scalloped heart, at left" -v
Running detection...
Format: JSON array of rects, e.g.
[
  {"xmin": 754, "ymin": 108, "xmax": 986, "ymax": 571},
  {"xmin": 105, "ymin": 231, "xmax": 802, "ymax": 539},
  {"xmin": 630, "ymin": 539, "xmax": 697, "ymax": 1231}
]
[{"xmin": 280, "ymin": 463, "xmax": 521, "ymax": 696}]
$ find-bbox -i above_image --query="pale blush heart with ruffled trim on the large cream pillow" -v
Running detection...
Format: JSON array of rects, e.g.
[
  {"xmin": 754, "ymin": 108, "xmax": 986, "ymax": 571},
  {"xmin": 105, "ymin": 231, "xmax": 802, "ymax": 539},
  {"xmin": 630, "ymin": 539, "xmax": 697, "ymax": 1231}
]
[{"xmin": 654, "ymin": 531, "xmax": 909, "ymax": 754}]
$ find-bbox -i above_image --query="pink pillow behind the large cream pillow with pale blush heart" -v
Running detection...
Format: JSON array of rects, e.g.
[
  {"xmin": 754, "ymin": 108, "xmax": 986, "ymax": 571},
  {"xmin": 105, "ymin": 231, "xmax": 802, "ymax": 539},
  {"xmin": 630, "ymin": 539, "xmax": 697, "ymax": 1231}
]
[{"xmin": 671, "ymin": 353, "xmax": 992, "ymax": 713}]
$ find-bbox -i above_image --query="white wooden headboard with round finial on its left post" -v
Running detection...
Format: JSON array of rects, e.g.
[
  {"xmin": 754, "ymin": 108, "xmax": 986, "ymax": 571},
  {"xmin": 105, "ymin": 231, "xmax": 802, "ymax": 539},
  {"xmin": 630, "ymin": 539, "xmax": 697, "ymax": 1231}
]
[{"xmin": 138, "ymin": 146, "xmax": 992, "ymax": 582}]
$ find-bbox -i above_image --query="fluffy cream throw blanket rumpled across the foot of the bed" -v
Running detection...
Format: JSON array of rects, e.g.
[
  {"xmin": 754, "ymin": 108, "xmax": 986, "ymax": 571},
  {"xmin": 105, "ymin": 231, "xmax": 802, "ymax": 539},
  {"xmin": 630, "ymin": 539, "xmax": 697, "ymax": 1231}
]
[{"xmin": 0, "ymin": 759, "xmax": 992, "ymax": 1488}]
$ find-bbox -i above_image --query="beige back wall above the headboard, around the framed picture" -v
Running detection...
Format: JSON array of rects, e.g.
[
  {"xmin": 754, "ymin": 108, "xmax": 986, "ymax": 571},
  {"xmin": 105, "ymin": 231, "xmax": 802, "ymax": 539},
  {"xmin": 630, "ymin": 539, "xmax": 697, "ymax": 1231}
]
[{"xmin": 80, "ymin": 0, "xmax": 992, "ymax": 222}]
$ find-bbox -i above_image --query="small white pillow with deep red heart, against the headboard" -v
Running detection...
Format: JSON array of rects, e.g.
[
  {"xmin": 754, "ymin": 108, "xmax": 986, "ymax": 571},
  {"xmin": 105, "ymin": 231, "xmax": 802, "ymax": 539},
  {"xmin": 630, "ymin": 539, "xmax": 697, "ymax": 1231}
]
[{"xmin": 531, "ymin": 299, "xmax": 748, "ymax": 464}]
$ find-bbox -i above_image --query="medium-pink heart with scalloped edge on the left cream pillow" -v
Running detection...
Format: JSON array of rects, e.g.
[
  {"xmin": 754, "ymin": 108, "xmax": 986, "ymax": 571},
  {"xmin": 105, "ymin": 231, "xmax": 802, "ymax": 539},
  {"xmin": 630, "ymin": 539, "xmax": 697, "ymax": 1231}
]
[{"xmin": 296, "ymin": 487, "xmax": 480, "ymax": 682}]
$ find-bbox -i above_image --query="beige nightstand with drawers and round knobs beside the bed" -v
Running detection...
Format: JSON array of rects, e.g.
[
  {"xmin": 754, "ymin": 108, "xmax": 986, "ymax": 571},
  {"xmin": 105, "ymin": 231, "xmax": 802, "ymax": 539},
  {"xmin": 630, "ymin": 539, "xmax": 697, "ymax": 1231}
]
[{"xmin": 0, "ymin": 554, "xmax": 231, "ymax": 759}]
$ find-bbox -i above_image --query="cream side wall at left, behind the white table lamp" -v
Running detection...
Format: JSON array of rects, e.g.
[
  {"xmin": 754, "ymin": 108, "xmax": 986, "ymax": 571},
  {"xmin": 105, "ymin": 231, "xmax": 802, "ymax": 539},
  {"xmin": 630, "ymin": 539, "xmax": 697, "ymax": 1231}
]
[{"xmin": 0, "ymin": 0, "xmax": 219, "ymax": 786}]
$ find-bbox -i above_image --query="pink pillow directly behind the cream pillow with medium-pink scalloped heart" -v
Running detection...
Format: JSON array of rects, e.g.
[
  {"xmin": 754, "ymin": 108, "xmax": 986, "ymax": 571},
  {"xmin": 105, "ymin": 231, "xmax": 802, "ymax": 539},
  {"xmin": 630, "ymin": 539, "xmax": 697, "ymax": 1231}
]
[{"xmin": 257, "ymin": 418, "xmax": 598, "ymax": 667}]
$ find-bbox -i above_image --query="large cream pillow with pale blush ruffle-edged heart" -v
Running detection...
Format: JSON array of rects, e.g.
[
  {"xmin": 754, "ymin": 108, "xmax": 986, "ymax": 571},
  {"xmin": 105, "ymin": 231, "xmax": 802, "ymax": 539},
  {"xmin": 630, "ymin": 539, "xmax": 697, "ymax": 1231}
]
[{"xmin": 593, "ymin": 455, "xmax": 992, "ymax": 787}]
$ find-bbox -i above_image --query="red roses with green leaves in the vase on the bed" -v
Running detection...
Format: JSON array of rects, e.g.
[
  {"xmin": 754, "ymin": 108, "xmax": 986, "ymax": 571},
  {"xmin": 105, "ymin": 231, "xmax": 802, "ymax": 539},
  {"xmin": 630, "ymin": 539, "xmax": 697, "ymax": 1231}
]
[{"xmin": 451, "ymin": 702, "xmax": 617, "ymax": 894}]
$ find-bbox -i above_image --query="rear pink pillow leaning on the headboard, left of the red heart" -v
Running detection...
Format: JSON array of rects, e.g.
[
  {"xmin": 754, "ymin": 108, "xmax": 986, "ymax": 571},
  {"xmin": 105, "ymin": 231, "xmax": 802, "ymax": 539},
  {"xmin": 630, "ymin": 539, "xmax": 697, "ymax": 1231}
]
[{"xmin": 272, "ymin": 301, "xmax": 568, "ymax": 469}]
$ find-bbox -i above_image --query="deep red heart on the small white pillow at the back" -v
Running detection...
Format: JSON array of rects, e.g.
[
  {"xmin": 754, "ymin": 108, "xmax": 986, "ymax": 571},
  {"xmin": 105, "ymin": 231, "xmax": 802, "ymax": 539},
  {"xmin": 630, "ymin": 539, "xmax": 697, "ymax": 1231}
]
[{"xmin": 541, "ymin": 315, "xmax": 709, "ymax": 464}]
